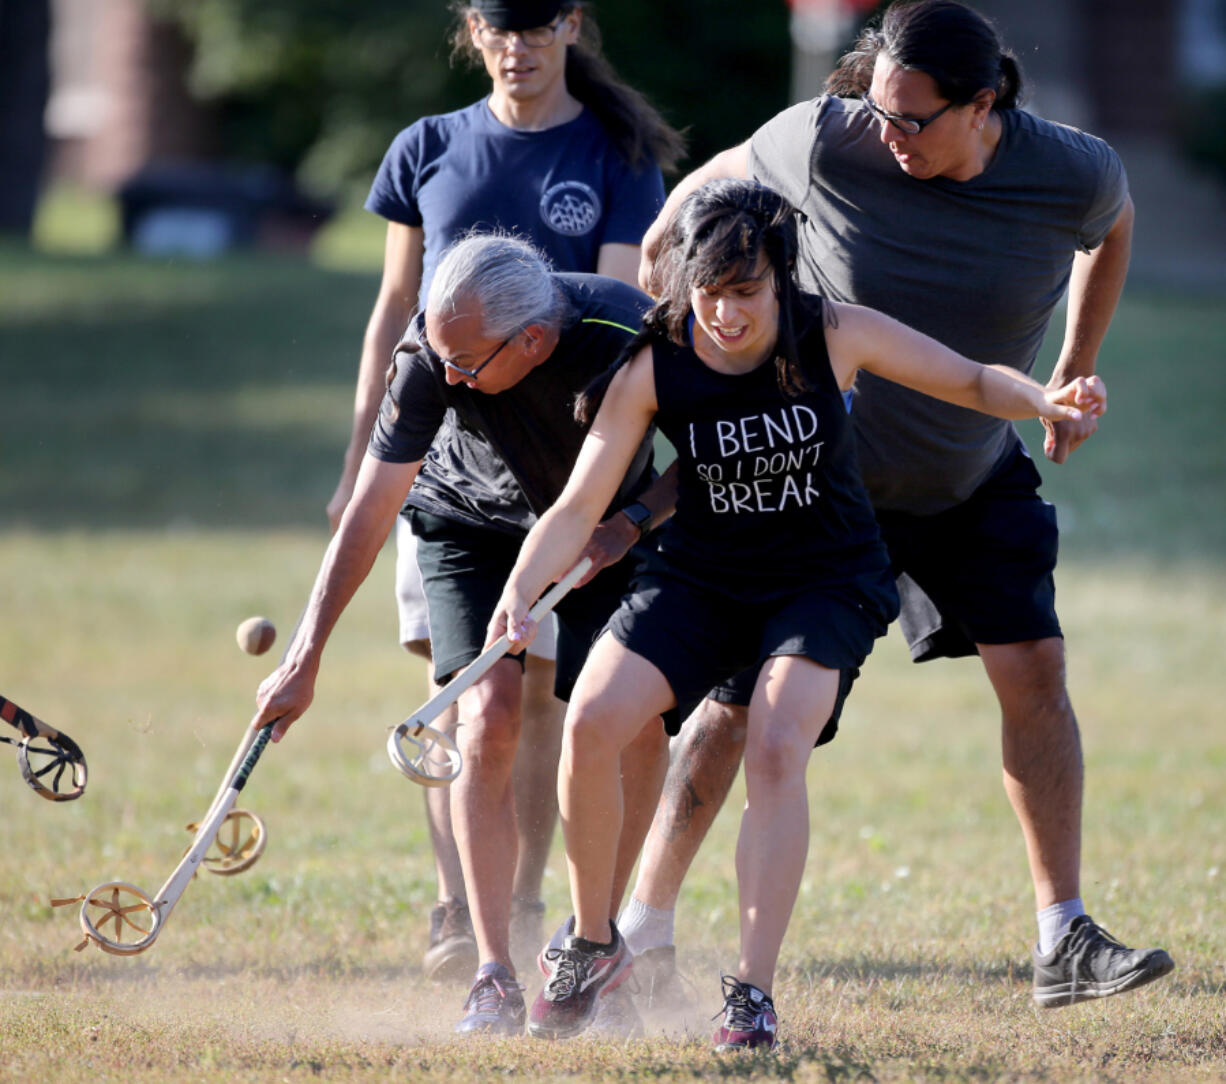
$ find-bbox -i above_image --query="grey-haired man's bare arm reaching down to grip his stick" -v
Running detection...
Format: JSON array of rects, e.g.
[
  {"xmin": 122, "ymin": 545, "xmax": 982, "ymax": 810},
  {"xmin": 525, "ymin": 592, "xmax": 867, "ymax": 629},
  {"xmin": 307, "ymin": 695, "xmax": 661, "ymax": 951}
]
[{"xmin": 253, "ymin": 455, "xmax": 421, "ymax": 742}]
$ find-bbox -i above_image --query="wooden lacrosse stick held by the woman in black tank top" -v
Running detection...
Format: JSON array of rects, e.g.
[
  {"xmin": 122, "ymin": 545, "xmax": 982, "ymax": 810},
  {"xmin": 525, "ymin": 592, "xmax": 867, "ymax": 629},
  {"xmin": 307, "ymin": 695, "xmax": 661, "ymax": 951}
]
[{"xmin": 387, "ymin": 557, "xmax": 592, "ymax": 787}]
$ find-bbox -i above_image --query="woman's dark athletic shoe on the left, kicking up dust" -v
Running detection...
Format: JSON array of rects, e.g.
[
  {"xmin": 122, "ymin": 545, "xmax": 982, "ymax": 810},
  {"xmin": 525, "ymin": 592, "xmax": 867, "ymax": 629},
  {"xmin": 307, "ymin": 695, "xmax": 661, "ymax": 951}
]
[{"xmin": 528, "ymin": 923, "xmax": 630, "ymax": 1039}]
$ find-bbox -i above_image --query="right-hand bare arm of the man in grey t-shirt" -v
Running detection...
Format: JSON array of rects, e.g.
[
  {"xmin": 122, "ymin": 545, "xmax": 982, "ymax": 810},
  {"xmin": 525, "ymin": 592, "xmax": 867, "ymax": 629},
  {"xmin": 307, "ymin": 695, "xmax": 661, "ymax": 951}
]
[{"xmin": 1043, "ymin": 199, "xmax": 1135, "ymax": 464}]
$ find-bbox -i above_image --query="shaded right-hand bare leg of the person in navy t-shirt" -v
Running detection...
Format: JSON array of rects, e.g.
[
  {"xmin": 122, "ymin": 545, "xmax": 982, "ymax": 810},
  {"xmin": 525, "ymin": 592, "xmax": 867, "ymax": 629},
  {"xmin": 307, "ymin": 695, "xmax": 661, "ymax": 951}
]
[{"xmin": 514, "ymin": 655, "xmax": 566, "ymax": 900}]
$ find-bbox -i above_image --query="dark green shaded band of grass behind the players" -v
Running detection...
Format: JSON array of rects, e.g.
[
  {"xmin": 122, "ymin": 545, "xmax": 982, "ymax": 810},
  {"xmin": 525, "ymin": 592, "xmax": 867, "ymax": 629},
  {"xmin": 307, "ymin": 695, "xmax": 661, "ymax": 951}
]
[{"xmin": 0, "ymin": 248, "xmax": 1226, "ymax": 560}]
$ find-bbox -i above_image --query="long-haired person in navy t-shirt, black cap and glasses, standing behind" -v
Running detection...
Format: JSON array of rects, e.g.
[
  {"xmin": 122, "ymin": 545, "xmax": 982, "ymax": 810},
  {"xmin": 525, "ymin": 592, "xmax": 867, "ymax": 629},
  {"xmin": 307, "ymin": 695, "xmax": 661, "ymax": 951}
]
[{"xmin": 327, "ymin": 0, "xmax": 682, "ymax": 1034}]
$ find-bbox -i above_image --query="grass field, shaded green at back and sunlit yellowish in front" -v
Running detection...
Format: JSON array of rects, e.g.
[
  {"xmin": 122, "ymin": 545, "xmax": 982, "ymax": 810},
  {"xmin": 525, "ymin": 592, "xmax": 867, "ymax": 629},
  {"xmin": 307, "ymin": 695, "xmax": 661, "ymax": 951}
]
[{"xmin": 0, "ymin": 232, "xmax": 1226, "ymax": 1084}]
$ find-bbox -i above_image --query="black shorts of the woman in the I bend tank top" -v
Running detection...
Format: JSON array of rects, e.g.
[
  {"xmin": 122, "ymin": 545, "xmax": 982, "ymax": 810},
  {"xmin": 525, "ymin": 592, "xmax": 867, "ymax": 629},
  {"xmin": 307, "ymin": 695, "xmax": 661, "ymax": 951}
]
[{"xmin": 608, "ymin": 555, "xmax": 897, "ymax": 746}]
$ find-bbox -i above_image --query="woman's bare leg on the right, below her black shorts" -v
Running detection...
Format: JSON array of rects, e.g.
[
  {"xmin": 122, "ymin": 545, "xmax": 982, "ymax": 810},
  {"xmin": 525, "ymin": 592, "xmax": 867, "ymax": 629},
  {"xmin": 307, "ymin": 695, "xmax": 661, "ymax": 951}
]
[{"xmin": 737, "ymin": 655, "xmax": 839, "ymax": 994}]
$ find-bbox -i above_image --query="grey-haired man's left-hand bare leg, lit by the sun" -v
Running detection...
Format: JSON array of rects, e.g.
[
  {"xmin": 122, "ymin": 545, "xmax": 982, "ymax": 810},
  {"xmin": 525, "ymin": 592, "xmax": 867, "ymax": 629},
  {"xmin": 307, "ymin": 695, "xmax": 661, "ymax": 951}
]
[{"xmin": 450, "ymin": 658, "xmax": 524, "ymax": 972}]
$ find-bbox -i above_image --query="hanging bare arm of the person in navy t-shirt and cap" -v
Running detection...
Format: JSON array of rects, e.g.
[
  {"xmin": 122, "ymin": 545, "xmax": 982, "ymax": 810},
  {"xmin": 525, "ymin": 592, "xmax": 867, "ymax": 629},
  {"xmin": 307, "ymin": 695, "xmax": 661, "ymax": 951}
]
[{"xmin": 327, "ymin": 222, "xmax": 425, "ymax": 531}]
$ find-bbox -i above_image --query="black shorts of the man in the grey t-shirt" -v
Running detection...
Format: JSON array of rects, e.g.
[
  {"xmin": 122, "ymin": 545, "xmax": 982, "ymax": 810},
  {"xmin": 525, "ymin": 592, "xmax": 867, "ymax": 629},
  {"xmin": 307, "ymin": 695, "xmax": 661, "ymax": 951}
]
[{"xmin": 877, "ymin": 441, "xmax": 1060, "ymax": 662}]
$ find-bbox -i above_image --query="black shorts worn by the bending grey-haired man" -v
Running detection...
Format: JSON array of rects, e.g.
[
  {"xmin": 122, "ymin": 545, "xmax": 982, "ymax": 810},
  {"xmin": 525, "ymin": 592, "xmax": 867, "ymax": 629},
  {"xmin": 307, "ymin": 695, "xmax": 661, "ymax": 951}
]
[{"xmin": 408, "ymin": 508, "xmax": 638, "ymax": 700}]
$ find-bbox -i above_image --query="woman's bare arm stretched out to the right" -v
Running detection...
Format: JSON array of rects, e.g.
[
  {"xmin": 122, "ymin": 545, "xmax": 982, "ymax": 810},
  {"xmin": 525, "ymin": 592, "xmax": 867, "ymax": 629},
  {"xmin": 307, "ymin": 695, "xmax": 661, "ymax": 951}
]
[{"xmin": 826, "ymin": 303, "xmax": 1107, "ymax": 421}]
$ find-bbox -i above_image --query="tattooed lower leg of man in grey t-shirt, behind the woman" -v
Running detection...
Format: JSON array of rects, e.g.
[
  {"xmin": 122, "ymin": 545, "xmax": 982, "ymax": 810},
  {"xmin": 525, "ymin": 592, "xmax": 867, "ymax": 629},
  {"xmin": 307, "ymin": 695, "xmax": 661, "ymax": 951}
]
[{"xmin": 634, "ymin": 700, "xmax": 748, "ymax": 911}]
